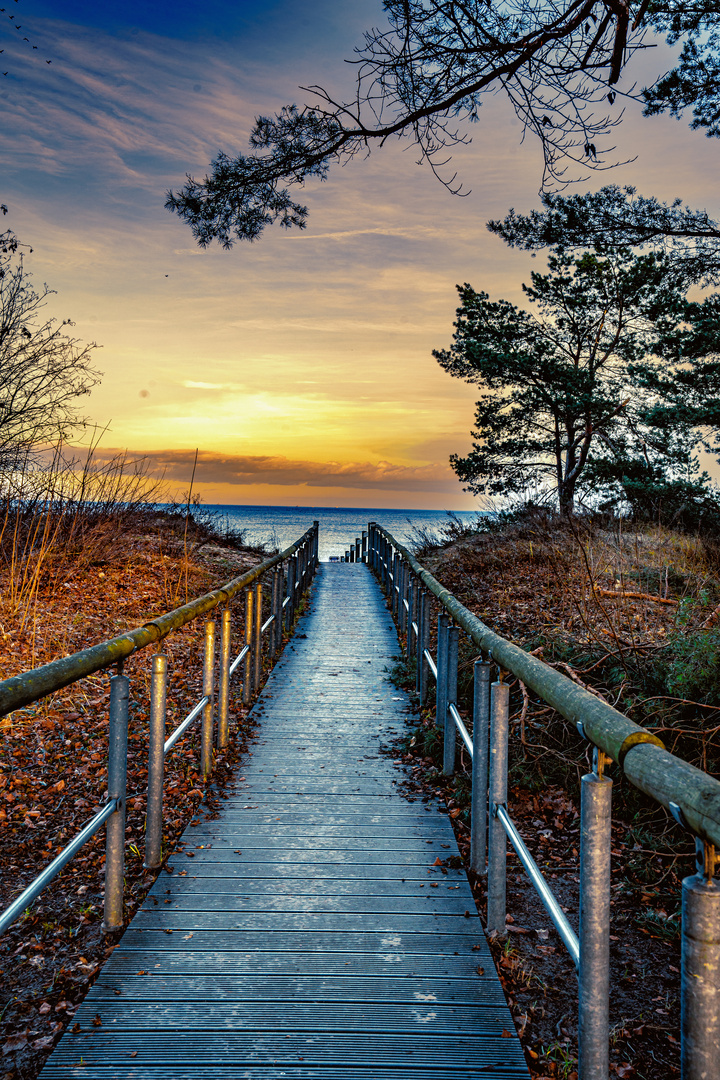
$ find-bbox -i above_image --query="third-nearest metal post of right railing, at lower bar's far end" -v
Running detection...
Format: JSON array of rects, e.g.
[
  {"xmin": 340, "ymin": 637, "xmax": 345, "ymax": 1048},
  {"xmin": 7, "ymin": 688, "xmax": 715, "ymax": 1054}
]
[{"xmin": 487, "ymin": 683, "xmax": 510, "ymax": 934}]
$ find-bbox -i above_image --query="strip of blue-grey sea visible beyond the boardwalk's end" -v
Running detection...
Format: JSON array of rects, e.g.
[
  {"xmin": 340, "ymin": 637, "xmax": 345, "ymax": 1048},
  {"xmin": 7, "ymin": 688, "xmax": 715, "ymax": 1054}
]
[{"xmin": 195, "ymin": 503, "xmax": 481, "ymax": 562}]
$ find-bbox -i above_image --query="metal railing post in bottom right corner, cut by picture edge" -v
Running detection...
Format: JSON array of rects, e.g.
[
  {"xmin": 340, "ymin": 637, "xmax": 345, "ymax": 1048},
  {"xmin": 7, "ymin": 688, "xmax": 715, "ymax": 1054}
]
[{"xmin": 680, "ymin": 842, "xmax": 720, "ymax": 1080}]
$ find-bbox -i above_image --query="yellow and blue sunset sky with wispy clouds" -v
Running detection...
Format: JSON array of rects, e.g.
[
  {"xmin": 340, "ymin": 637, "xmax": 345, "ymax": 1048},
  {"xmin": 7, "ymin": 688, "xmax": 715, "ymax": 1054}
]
[{"xmin": 0, "ymin": 0, "xmax": 720, "ymax": 510}]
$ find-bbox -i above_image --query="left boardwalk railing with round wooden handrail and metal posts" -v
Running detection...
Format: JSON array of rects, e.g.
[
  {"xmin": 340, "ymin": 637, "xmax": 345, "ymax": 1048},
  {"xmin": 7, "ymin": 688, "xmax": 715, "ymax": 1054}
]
[{"xmin": 0, "ymin": 522, "xmax": 318, "ymax": 933}]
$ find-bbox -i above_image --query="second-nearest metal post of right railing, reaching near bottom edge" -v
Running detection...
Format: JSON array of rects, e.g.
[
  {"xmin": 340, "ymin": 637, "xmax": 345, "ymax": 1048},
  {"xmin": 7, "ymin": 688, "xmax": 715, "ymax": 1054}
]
[{"xmin": 578, "ymin": 764, "xmax": 612, "ymax": 1080}]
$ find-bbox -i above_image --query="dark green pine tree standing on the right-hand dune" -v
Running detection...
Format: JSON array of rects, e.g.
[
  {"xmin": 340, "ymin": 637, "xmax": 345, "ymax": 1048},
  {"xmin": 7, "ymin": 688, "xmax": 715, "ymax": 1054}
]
[{"xmin": 434, "ymin": 248, "xmax": 720, "ymax": 512}]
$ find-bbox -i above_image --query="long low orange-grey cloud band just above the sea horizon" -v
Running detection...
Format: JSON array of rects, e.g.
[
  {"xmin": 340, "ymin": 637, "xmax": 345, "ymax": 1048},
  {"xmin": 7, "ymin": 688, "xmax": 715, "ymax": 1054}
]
[{"xmin": 96, "ymin": 449, "xmax": 457, "ymax": 492}]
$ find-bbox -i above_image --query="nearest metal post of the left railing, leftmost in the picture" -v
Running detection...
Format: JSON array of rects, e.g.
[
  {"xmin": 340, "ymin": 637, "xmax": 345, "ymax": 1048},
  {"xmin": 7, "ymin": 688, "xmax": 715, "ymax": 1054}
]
[{"xmin": 103, "ymin": 675, "xmax": 130, "ymax": 931}]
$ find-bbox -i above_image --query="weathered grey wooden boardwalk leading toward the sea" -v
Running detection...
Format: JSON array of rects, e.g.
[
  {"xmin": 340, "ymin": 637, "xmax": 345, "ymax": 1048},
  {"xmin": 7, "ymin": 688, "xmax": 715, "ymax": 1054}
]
[{"xmin": 42, "ymin": 564, "xmax": 528, "ymax": 1080}]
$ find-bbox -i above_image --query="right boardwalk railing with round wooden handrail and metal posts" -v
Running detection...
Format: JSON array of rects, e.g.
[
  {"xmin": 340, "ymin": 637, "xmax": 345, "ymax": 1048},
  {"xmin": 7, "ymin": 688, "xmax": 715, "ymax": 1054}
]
[{"xmin": 369, "ymin": 522, "xmax": 720, "ymax": 1080}]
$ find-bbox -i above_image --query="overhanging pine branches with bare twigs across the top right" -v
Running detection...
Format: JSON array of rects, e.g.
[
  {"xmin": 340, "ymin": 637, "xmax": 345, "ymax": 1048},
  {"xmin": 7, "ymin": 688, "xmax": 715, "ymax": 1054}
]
[{"xmin": 166, "ymin": 0, "xmax": 720, "ymax": 247}]
